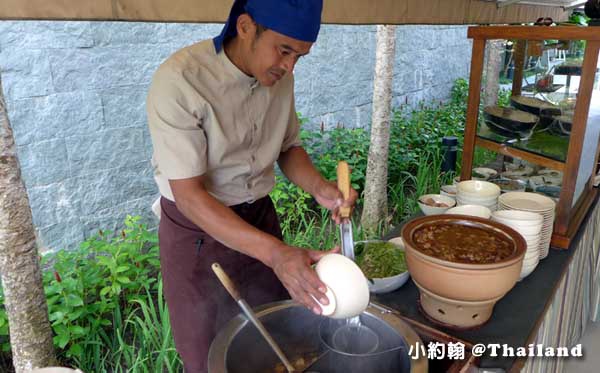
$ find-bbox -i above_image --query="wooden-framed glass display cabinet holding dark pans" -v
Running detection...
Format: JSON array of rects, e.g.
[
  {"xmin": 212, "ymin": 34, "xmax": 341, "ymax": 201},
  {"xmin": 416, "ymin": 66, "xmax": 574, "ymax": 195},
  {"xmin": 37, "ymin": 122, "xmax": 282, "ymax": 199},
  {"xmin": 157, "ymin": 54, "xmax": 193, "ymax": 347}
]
[{"xmin": 461, "ymin": 26, "xmax": 600, "ymax": 248}]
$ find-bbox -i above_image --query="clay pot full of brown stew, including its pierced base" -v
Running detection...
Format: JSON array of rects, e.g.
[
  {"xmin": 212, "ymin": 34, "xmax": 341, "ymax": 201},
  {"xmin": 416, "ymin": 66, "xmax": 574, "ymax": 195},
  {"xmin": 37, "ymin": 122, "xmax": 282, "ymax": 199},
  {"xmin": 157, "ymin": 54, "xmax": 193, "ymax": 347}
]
[{"xmin": 402, "ymin": 214, "xmax": 527, "ymax": 328}]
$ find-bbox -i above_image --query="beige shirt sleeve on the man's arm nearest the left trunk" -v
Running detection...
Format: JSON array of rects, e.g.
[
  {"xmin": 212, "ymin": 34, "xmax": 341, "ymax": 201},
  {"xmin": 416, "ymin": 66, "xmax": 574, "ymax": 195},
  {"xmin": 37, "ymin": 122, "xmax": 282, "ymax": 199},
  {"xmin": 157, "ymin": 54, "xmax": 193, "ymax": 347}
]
[{"xmin": 146, "ymin": 66, "xmax": 208, "ymax": 180}]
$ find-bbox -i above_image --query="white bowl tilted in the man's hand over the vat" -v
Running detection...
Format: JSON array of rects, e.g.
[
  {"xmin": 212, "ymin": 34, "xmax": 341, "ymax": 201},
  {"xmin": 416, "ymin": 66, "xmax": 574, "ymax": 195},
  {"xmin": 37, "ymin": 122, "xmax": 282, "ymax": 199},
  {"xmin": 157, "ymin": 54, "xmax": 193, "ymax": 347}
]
[{"xmin": 315, "ymin": 254, "xmax": 369, "ymax": 319}]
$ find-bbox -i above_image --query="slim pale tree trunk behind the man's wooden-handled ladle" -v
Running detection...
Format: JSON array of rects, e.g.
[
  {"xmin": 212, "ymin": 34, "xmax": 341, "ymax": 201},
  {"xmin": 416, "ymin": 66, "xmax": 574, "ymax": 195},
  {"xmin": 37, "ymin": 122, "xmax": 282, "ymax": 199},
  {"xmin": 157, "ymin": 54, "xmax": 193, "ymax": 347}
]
[{"xmin": 361, "ymin": 25, "xmax": 396, "ymax": 229}]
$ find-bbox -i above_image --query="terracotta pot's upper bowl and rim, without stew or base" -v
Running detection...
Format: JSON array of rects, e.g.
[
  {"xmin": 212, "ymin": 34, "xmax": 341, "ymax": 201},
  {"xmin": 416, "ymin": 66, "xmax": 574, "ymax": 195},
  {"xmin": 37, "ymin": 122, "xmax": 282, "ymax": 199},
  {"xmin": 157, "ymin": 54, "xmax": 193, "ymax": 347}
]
[{"xmin": 402, "ymin": 214, "xmax": 527, "ymax": 302}]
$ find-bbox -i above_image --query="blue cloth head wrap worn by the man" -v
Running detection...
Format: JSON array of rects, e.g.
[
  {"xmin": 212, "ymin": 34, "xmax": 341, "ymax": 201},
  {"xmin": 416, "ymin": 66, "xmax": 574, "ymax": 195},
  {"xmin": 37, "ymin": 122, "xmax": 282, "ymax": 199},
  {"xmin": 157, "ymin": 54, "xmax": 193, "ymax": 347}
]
[{"xmin": 213, "ymin": 0, "xmax": 323, "ymax": 52}]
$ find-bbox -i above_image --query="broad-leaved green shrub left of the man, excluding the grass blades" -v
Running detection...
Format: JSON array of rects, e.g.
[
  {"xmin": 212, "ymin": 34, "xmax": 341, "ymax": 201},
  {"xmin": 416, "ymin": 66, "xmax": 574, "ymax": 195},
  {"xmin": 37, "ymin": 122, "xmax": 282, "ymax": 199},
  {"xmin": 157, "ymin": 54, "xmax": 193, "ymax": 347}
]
[{"xmin": 42, "ymin": 216, "xmax": 159, "ymax": 359}]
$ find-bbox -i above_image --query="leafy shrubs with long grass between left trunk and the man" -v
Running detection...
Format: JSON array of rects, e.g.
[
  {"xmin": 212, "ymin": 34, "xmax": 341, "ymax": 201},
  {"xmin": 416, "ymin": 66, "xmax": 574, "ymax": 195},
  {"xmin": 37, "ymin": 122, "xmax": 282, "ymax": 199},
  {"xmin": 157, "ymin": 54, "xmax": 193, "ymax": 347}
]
[{"xmin": 0, "ymin": 216, "xmax": 180, "ymax": 372}]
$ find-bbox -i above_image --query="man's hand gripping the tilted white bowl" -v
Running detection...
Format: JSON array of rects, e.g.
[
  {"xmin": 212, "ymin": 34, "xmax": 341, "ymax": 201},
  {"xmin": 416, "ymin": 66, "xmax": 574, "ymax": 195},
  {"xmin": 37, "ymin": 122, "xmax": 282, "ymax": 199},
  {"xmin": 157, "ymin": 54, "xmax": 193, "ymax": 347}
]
[{"xmin": 271, "ymin": 244, "xmax": 329, "ymax": 315}]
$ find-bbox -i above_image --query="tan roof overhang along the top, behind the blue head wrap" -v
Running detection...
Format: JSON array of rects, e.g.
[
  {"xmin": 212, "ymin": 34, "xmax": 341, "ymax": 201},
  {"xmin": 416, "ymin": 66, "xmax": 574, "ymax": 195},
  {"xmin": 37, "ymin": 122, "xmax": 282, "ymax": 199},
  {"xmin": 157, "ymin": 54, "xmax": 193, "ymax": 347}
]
[{"xmin": 0, "ymin": 0, "xmax": 572, "ymax": 25}]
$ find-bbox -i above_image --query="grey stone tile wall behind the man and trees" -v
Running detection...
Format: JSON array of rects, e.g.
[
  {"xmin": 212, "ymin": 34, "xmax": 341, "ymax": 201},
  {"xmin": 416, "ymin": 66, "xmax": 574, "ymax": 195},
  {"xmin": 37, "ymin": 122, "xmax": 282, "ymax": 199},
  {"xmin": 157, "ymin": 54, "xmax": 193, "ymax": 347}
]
[{"xmin": 0, "ymin": 21, "xmax": 471, "ymax": 250}]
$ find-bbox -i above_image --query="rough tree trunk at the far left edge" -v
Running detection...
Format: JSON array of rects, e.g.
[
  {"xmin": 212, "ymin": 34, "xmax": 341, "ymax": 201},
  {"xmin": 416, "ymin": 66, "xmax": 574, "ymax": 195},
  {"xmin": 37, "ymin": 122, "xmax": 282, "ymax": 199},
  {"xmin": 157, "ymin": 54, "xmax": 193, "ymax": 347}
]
[{"xmin": 0, "ymin": 72, "xmax": 55, "ymax": 373}]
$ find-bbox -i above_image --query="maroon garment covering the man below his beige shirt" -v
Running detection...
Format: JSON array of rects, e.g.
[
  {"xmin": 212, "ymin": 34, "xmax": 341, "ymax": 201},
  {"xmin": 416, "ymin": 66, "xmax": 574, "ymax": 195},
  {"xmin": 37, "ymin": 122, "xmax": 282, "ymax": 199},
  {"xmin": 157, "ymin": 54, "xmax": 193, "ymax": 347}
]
[{"xmin": 158, "ymin": 196, "xmax": 289, "ymax": 373}]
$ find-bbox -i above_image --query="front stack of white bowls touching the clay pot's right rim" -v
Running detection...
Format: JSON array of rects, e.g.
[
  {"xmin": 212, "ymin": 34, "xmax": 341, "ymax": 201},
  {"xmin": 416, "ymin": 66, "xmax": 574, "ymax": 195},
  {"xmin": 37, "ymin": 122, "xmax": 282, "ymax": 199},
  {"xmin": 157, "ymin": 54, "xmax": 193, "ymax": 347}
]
[{"xmin": 492, "ymin": 210, "xmax": 544, "ymax": 279}]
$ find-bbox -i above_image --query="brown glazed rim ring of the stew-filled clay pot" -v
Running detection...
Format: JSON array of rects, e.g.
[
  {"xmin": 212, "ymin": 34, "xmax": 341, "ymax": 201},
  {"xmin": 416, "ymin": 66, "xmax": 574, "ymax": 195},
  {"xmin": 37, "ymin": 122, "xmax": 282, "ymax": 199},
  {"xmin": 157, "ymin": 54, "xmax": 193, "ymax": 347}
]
[{"xmin": 402, "ymin": 214, "xmax": 527, "ymax": 270}]
